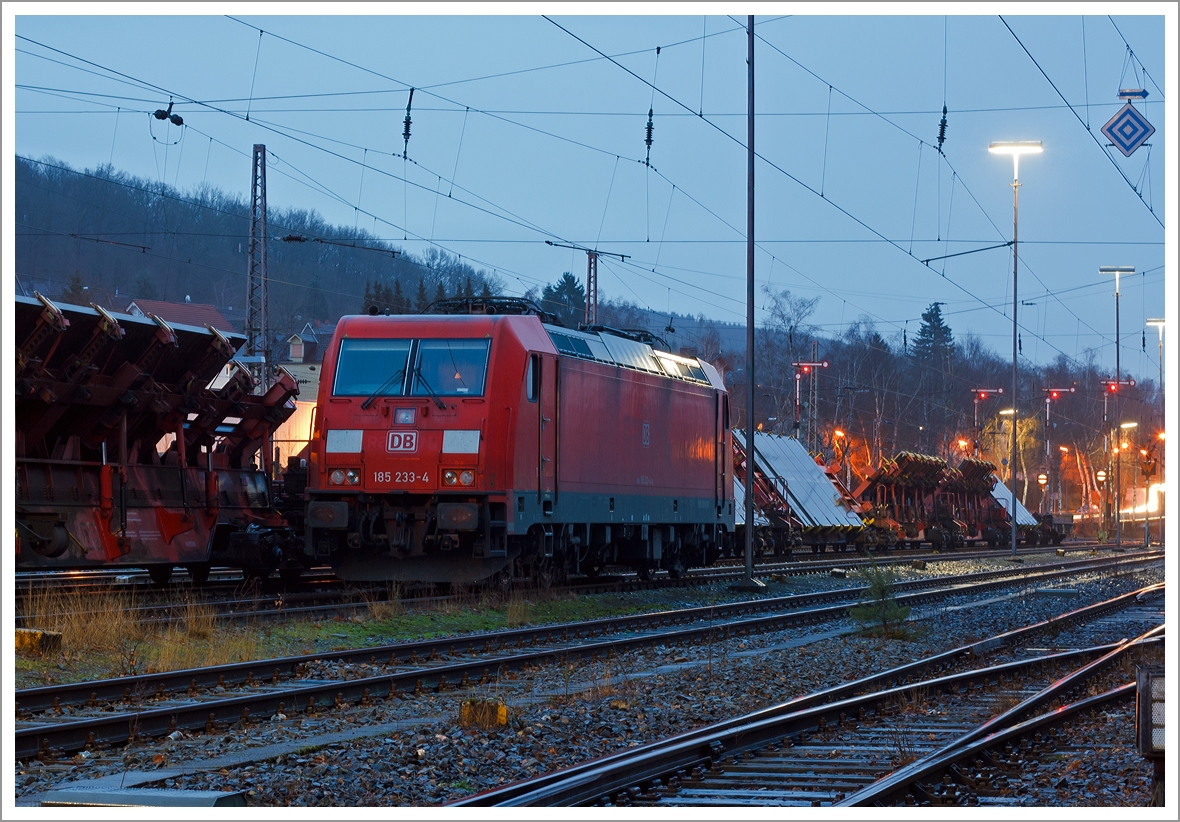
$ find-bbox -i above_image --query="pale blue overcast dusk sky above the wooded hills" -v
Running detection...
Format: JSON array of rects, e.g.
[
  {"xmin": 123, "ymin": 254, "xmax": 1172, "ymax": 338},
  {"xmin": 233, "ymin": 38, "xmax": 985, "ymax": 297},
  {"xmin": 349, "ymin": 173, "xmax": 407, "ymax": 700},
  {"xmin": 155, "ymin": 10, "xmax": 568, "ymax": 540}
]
[{"xmin": 4, "ymin": 4, "xmax": 1176, "ymax": 376}]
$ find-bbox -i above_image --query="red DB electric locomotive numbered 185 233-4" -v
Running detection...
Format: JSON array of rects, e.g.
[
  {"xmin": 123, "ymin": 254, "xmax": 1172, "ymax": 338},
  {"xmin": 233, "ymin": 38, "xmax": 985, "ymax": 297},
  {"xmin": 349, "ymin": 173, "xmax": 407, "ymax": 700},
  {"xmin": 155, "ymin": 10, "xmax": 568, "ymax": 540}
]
[{"xmin": 304, "ymin": 298, "xmax": 734, "ymax": 585}]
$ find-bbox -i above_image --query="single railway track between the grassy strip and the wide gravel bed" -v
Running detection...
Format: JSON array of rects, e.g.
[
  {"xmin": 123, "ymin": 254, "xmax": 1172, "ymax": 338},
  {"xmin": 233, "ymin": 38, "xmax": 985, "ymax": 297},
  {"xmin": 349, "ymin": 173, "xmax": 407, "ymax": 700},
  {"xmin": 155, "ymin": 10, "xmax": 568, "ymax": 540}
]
[{"xmin": 14, "ymin": 552, "xmax": 1162, "ymax": 758}]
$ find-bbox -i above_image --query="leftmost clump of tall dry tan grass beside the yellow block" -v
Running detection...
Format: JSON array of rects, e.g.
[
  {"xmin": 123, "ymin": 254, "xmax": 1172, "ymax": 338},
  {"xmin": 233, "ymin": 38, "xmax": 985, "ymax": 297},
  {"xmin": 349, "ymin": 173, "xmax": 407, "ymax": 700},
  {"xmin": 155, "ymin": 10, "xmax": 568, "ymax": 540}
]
[{"xmin": 20, "ymin": 587, "xmax": 144, "ymax": 653}]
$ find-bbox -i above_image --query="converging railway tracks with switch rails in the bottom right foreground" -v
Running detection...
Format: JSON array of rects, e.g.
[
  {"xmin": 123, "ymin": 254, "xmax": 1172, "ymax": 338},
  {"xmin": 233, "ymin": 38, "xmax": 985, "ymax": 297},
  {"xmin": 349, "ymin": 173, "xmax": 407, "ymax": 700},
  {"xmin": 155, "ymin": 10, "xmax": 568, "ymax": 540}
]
[{"xmin": 452, "ymin": 586, "xmax": 1163, "ymax": 808}]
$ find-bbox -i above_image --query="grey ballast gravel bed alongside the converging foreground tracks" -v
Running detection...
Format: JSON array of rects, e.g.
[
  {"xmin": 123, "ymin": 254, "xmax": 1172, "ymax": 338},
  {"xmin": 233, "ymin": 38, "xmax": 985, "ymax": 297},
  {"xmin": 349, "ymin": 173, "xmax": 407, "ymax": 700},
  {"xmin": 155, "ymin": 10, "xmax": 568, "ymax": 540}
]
[{"xmin": 15, "ymin": 561, "xmax": 1163, "ymax": 808}]
